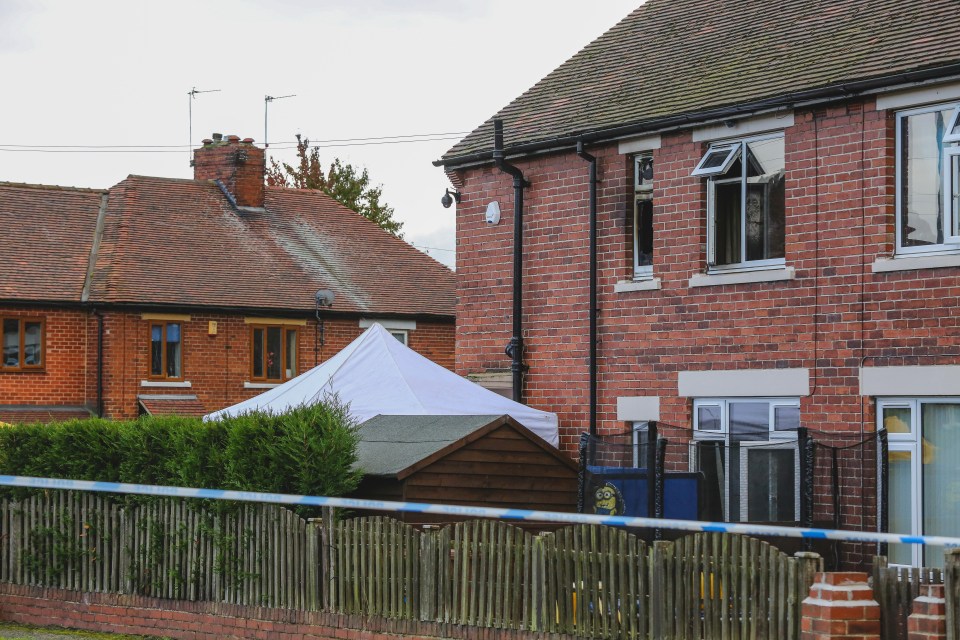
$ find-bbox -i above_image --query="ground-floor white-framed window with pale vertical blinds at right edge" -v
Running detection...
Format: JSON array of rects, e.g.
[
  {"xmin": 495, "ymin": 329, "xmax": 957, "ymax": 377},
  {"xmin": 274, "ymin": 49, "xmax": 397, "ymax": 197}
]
[{"xmin": 877, "ymin": 398, "xmax": 960, "ymax": 567}]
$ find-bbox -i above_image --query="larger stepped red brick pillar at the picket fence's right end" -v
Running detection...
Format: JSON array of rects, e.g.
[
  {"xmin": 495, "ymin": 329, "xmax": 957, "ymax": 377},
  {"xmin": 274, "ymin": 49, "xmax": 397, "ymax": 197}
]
[{"xmin": 800, "ymin": 572, "xmax": 880, "ymax": 640}]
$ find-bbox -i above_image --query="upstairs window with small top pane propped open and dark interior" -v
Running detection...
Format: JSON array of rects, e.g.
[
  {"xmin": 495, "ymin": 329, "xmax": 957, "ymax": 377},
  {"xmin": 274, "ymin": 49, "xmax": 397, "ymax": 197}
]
[{"xmin": 692, "ymin": 134, "xmax": 785, "ymax": 271}]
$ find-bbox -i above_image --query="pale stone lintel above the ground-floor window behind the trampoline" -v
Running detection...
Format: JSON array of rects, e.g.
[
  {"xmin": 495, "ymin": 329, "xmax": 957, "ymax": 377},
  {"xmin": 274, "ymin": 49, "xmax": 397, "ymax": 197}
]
[{"xmin": 677, "ymin": 369, "xmax": 810, "ymax": 398}]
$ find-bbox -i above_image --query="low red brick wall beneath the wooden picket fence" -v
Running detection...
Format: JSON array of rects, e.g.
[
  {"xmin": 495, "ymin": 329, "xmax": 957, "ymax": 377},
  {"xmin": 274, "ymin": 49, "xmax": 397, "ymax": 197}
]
[{"xmin": 0, "ymin": 584, "xmax": 572, "ymax": 640}]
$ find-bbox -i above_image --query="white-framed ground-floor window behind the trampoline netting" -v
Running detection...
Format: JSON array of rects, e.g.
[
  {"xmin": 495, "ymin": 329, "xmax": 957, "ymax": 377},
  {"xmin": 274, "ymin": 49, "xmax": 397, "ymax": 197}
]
[{"xmin": 691, "ymin": 398, "xmax": 800, "ymax": 522}]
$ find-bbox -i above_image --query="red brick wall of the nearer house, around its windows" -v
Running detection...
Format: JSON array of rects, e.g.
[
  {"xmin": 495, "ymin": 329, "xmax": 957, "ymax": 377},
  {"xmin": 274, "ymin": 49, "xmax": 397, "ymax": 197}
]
[{"xmin": 457, "ymin": 100, "xmax": 960, "ymax": 516}]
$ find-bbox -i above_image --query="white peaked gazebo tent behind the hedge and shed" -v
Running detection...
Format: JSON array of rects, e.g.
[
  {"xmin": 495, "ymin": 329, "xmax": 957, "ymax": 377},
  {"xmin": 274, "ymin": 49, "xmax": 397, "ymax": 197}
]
[{"xmin": 205, "ymin": 324, "xmax": 559, "ymax": 446}]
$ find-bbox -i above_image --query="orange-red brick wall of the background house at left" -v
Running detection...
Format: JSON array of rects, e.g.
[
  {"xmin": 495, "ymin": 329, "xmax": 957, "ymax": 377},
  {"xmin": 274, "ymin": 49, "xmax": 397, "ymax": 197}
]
[{"xmin": 0, "ymin": 307, "xmax": 454, "ymax": 419}]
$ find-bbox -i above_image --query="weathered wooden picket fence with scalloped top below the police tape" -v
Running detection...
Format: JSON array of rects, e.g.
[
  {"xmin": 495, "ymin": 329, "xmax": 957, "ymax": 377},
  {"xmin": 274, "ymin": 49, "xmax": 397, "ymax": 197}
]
[{"xmin": 0, "ymin": 491, "xmax": 822, "ymax": 640}]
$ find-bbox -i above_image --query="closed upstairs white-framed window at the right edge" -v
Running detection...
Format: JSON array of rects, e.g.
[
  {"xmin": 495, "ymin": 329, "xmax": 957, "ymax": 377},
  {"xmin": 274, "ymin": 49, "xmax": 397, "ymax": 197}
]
[{"xmin": 896, "ymin": 104, "xmax": 960, "ymax": 255}]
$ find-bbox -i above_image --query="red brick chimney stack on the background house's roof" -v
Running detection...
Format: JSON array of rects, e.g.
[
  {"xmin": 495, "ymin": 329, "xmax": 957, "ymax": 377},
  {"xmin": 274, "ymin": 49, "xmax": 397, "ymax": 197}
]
[{"xmin": 193, "ymin": 133, "xmax": 266, "ymax": 207}]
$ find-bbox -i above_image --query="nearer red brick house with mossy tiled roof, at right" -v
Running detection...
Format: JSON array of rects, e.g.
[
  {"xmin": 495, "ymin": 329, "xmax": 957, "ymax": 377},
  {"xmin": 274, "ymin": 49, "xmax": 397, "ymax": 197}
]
[{"xmin": 438, "ymin": 0, "xmax": 960, "ymax": 563}]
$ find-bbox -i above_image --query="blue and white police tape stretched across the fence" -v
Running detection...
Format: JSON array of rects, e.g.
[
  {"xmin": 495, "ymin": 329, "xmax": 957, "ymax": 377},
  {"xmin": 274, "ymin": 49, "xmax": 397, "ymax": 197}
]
[{"xmin": 0, "ymin": 475, "xmax": 960, "ymax": 547}]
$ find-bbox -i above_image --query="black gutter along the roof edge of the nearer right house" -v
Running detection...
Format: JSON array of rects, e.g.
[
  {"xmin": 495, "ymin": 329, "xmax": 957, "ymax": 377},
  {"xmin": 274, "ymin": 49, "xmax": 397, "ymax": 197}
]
[{"xmin": 433, "ymin": 64, "xmax": 960, "ymax": 169}]
